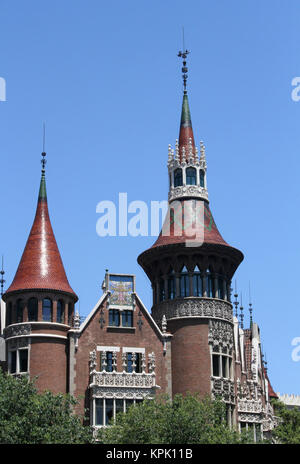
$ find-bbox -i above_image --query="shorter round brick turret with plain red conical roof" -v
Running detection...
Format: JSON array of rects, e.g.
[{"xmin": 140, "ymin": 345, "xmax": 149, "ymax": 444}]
[{"xmin": 3, "ymin": 148, "xmax": 78, "ymax": 393}]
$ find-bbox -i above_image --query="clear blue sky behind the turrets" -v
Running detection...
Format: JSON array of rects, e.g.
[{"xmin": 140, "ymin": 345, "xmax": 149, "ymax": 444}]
[{"xmin": 0, "ymin": 0, "xmax": 300, "ymax": 394}]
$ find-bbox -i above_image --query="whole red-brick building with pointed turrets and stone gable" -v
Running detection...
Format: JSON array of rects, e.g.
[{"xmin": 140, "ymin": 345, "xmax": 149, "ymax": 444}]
[{"xmin": 0, "ymin": 51, "xmax": 276, "ymax": 436}]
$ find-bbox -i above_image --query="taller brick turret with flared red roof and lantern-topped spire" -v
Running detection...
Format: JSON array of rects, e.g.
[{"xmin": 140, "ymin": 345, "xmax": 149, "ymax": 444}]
[{"xmin": 138, "ymin": 50, "xmax": 243, "ymax": 420}]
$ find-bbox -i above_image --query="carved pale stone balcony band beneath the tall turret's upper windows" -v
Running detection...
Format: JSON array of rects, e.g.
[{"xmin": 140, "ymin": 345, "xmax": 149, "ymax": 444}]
[{"xmin": 152, "ymin": 297, "xmax": 233, "ymax": 325}]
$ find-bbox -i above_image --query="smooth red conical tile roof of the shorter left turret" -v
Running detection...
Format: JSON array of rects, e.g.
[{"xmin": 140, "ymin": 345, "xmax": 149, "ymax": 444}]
[{"xmin": 4, "ymin": 174, "xmax": 78, "ymax": 300}]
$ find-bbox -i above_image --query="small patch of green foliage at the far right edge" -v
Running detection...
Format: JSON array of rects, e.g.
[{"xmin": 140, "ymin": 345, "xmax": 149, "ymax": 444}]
[{"xmin": 272, "ymin": 400, "xmax": 300, "ymax": 444}]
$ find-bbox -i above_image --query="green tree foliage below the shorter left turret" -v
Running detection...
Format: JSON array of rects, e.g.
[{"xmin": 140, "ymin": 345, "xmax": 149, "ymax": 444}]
[{"xmin": 0, "ymin": 369, "xmax": 93, "ymax": 444}]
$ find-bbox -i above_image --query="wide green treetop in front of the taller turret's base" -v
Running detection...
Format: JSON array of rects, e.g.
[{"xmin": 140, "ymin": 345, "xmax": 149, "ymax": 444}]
[{"xmin": 98, "ymin": 395, "xmax": 255, "ymax": 444}]
